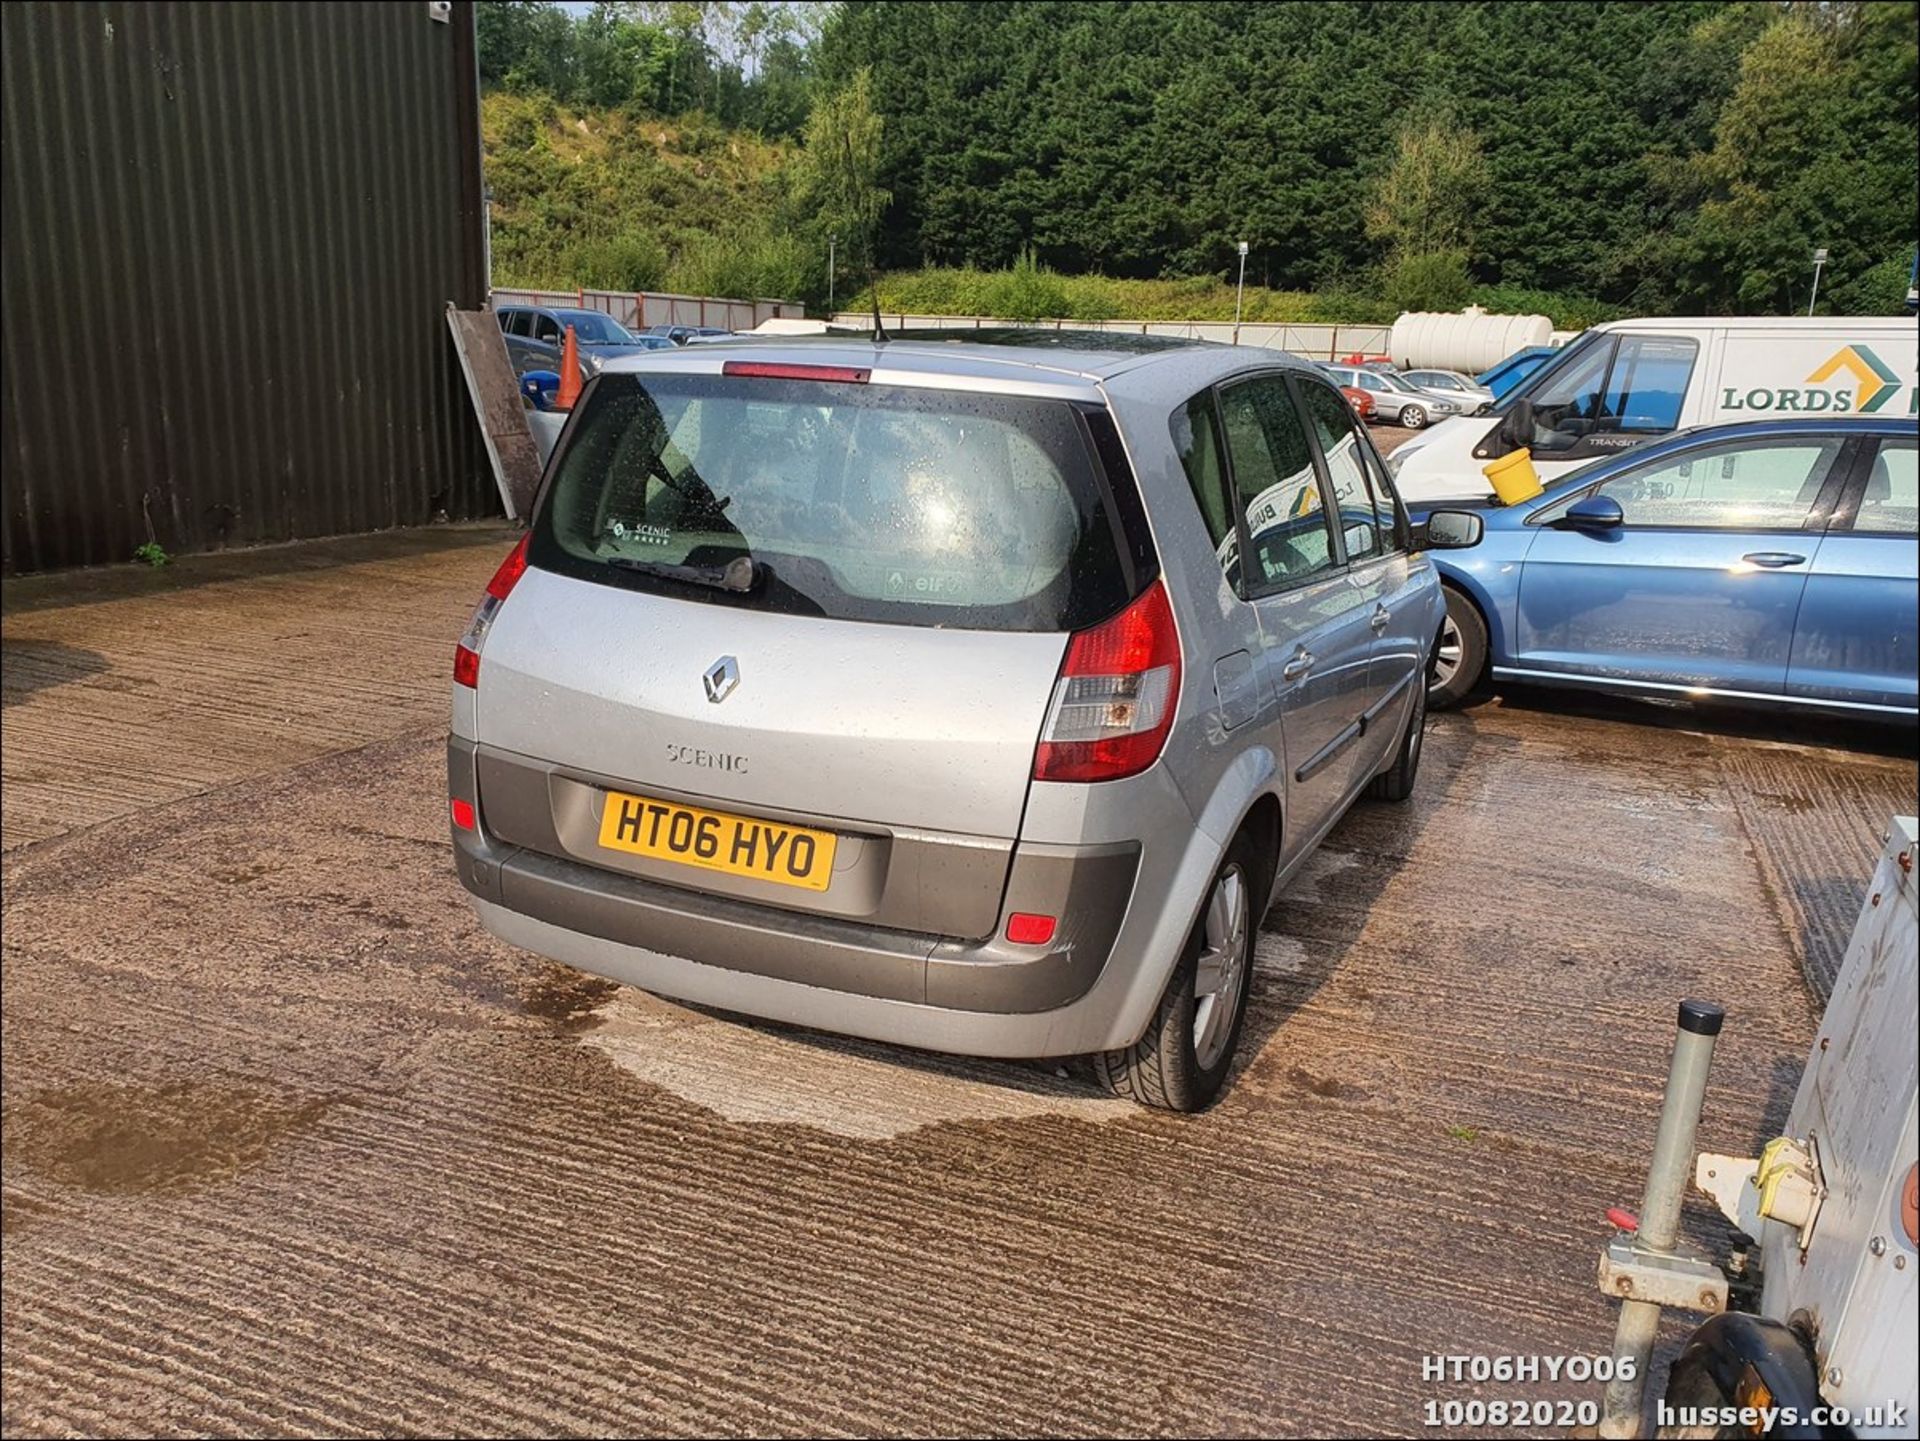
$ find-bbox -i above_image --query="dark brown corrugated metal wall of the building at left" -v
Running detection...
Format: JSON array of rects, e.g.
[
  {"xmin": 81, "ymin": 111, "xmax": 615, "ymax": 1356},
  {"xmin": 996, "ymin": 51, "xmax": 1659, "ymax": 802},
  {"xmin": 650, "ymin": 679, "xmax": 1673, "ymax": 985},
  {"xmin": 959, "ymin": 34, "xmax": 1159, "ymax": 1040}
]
[{"xmin": 0, "ymin": 0, "xmax": 499, "ymax": 572}]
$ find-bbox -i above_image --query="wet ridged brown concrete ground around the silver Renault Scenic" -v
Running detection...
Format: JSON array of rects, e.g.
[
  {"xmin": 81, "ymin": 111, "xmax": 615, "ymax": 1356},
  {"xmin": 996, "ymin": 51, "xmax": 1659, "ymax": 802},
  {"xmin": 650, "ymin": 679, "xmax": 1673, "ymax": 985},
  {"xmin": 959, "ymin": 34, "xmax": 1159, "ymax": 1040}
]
[{"xmin": 0, "ymin": 528, "xmax": 1916, "ymax": 1435}]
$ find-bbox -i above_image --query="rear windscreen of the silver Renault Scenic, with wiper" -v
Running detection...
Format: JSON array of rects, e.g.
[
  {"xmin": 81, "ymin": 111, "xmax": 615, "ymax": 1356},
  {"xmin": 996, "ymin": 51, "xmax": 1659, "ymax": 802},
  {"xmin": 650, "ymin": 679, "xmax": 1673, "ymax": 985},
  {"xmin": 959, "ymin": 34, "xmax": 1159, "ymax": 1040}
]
[{"xmin": 528, "ymin": 374, "xmax": 1131, "ymax": 631}]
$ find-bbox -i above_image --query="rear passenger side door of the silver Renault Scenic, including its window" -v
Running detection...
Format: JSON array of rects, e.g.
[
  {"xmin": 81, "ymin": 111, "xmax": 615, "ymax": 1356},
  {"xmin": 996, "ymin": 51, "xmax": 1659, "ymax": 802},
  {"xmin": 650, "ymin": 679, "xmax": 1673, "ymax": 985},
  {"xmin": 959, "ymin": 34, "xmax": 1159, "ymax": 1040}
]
[{"xmin": 1219, "ymin": 374, "xmax": 1375, "ymax": 850}]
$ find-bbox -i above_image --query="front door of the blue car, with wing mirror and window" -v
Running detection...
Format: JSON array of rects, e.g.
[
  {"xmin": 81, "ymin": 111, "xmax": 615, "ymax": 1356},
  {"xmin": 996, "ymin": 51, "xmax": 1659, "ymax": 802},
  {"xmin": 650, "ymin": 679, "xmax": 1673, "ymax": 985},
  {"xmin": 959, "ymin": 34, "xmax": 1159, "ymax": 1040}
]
[{"xmin": 1501, "ymin": 436, "xmax": 1843, "ymax": 695}]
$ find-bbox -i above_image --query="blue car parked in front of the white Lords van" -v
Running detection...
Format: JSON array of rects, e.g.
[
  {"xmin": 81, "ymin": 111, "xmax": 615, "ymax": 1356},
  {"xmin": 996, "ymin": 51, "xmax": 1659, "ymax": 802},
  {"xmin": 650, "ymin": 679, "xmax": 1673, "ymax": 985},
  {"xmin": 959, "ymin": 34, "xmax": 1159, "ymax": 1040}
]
[{"xmin": 1427, "ymin": 416, "xmax": 1920, "ymax": 723}]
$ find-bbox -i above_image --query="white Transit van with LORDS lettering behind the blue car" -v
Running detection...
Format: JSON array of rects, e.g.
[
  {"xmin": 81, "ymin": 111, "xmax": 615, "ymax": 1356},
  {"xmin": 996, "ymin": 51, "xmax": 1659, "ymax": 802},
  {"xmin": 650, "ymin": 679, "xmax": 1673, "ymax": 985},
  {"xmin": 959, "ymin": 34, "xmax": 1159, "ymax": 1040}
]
[{"xmin": 1386, "ymin": 317, "xmax": 1920, "ymax": 507}]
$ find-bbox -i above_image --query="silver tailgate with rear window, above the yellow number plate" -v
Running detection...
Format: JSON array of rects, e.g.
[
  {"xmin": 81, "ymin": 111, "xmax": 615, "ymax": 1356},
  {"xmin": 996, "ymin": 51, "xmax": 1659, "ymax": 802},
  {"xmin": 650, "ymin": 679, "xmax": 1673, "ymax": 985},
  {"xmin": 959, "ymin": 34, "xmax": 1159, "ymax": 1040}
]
[{"xmin": 478, "ymin": 366, "xmax": 1150, "ymax": 840}]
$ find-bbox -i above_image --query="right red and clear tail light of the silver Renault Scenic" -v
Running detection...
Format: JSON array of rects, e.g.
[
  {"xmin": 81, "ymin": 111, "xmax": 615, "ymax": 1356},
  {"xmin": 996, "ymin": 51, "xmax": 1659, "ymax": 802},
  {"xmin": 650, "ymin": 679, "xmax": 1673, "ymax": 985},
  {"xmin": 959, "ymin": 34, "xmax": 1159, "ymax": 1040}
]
[{"xmin": 1033, "ymin": 581, "xmax": 1181, "ymax": 781}]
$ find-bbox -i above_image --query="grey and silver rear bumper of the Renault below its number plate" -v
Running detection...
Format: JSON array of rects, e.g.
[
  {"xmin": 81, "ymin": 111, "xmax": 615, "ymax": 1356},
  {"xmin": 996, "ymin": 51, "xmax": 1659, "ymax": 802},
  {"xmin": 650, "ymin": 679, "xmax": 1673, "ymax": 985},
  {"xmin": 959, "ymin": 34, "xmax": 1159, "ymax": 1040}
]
[{"xmin": 447, "ymin": 737, "xmax": 1140, "ymax": 1028}]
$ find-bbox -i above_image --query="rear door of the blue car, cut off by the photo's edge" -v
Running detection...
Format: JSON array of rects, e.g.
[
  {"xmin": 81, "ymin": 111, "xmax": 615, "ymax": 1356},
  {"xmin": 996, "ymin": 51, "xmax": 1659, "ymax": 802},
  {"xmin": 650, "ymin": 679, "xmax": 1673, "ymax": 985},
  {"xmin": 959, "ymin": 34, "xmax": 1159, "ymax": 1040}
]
[{"xmin": 1788, "ymin": 439, "xmax": 1920, "ymax": 710}]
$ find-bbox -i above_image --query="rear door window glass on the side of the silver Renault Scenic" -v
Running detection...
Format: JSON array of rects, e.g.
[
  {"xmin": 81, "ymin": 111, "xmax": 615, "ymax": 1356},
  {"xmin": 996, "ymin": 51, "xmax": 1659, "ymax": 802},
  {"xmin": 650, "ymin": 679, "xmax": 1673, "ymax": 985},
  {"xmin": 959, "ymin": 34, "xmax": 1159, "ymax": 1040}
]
[{"xmin": 1219, "ymin": 376, "xmax": 1334, "ymax": 595}]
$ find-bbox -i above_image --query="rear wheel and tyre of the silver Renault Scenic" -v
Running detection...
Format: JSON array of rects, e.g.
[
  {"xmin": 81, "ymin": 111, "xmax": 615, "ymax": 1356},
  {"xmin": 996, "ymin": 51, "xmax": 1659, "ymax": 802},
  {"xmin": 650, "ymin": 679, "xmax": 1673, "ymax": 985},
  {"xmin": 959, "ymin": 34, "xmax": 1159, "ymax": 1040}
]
[{"xmin": 1092, "ymin": 835, "xmax": 1273, "ymax": 1111}]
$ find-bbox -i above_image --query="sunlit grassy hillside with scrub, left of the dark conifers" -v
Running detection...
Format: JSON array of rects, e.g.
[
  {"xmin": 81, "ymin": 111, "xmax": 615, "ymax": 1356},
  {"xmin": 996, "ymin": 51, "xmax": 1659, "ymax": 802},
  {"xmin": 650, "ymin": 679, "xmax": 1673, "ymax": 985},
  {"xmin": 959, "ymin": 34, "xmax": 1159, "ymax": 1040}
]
[{"xmin": 480, "ymin": 92, "xmax": 804, "ymax": 295}]
